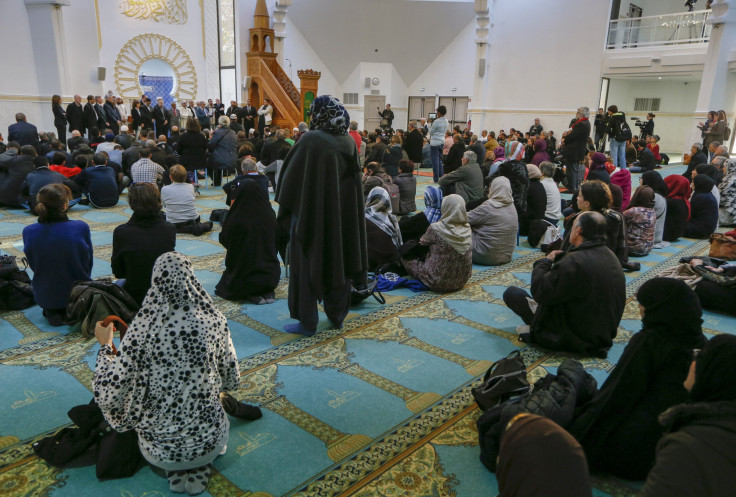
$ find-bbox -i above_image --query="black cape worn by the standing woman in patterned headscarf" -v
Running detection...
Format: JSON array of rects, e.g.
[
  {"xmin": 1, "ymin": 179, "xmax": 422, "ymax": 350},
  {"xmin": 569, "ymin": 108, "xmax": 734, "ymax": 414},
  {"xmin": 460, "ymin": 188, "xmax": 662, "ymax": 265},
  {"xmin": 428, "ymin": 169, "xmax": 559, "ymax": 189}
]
[{"xmin": 276, "ymin": 130, "xmax": 368, "ymax": 298}]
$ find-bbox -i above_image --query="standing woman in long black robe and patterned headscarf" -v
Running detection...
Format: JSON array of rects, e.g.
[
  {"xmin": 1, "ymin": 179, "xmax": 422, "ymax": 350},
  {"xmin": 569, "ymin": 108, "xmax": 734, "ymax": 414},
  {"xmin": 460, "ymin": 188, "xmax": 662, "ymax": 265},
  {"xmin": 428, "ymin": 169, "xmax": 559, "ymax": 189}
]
[{"xmin": 276, "ymin": 95, "xmax": 368, "ymax": 336}]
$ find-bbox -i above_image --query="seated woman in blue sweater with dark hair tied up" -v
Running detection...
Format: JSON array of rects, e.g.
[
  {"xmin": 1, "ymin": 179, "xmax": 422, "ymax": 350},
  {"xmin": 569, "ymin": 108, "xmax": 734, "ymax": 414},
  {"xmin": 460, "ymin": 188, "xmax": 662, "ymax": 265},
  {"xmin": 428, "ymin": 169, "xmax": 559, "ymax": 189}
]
[{"xmin": 23, "ymin": 183, "xmax": 92, "ymax": 326}]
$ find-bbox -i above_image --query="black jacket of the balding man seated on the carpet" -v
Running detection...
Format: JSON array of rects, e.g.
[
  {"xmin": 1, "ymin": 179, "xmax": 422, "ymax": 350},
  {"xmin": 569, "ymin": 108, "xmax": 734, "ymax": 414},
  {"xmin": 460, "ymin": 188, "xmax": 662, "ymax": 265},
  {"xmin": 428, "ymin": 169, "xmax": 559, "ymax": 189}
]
[{"xmin": 531, "ymin": 242, "xmax": 626, "ymax": 357}]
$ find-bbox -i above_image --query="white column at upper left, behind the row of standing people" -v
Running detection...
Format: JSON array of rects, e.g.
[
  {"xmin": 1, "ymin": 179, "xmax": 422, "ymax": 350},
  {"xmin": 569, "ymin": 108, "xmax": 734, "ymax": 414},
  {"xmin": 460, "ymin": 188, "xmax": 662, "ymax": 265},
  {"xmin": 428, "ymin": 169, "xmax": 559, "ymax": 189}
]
[{"xmin": 25, "ymin": 0, "xmax": 71, "ymax": 96}]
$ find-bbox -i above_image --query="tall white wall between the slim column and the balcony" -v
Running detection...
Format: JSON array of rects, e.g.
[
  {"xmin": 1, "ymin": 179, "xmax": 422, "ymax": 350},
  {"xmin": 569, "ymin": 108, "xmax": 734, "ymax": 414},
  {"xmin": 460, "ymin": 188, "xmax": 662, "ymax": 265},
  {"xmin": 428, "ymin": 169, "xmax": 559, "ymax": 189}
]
[{"xmin": 462, "ymin": 0, "xmax": 610, "ymax": 136}]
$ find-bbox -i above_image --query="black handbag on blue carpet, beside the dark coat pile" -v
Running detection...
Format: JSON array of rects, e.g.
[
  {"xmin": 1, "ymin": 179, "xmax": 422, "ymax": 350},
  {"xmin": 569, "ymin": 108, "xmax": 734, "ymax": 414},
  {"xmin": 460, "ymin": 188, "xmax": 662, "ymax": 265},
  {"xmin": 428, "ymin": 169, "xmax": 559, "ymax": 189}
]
[{"xmin": 470, "ymin": 350, "xmax": 531, "ymax": 411}]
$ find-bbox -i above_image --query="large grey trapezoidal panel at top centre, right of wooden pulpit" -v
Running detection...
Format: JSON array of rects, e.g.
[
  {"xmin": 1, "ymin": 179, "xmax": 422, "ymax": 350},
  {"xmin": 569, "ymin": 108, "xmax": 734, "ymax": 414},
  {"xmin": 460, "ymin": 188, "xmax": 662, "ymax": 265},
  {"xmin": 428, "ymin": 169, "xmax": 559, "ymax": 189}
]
[{"xmin": 288, "ymin": 0, "xmax": 475, "ymax": 84}]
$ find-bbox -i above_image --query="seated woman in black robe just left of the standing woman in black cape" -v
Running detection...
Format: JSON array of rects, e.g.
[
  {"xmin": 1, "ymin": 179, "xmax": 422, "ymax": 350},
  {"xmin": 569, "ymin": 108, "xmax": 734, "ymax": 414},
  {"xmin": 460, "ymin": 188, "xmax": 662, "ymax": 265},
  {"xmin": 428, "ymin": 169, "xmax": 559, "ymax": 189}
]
[{"xmin": 215, "ymin": 181, "xmax": 281, "ymax": 304}]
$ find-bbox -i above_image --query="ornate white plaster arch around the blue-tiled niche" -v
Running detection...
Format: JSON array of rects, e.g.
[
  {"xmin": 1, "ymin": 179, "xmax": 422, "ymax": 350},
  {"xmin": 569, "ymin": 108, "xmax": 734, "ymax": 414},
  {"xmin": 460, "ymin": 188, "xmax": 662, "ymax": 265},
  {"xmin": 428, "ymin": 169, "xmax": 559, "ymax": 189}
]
[{"xmin": 115, "ymin": 33, "xmax": 197, "ymax": 100}]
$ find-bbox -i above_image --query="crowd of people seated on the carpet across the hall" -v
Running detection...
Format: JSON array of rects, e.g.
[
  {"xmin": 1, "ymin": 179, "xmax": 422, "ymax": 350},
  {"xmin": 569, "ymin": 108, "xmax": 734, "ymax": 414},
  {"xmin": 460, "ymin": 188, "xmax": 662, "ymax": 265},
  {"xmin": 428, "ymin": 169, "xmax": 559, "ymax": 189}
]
[{"xmin": 0, "ymin": 99, "xmax": 736, "ymax": 497}]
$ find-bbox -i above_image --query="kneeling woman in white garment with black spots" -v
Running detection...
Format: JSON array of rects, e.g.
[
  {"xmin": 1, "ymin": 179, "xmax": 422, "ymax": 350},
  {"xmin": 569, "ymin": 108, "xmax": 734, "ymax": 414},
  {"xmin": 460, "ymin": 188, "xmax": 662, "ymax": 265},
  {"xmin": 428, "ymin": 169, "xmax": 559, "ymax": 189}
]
[{"xmin": 93, "ymin": 252, "xmax": 239, "ymax": 495}]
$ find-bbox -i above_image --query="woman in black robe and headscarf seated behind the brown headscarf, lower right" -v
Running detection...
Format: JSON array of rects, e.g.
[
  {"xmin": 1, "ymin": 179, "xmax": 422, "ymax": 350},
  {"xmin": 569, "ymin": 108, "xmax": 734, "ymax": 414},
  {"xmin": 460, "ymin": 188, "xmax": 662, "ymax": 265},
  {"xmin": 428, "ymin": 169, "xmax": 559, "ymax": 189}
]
[{"xmin": 570, "ymin": 278, "xmax": 706, "ymax": 480}]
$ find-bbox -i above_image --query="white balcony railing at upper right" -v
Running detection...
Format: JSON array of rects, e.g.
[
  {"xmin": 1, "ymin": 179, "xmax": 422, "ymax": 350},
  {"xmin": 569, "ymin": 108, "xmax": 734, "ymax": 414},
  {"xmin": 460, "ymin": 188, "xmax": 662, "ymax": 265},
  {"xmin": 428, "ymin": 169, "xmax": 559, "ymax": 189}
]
[{"xmin": 606, "ymin": 10, "xmax": 712, "ymax": 49}]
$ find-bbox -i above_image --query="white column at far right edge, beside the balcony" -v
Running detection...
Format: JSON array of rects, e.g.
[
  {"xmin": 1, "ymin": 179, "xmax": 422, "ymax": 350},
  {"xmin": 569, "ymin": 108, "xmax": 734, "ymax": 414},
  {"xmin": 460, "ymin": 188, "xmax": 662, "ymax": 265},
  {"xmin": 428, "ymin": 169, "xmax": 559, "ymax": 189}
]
[{"xmin": 682, "ymin": 0, "xmax": 736, "ymax": 153}]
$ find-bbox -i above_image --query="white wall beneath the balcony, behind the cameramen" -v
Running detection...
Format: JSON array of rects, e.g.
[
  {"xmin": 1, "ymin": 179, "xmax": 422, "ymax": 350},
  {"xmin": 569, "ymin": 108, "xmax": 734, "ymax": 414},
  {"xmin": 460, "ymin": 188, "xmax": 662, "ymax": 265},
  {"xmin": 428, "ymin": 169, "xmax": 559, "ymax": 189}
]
[{"xmin": 608, "ymin": 79, "xmax": 700, "ymax": 153}]
